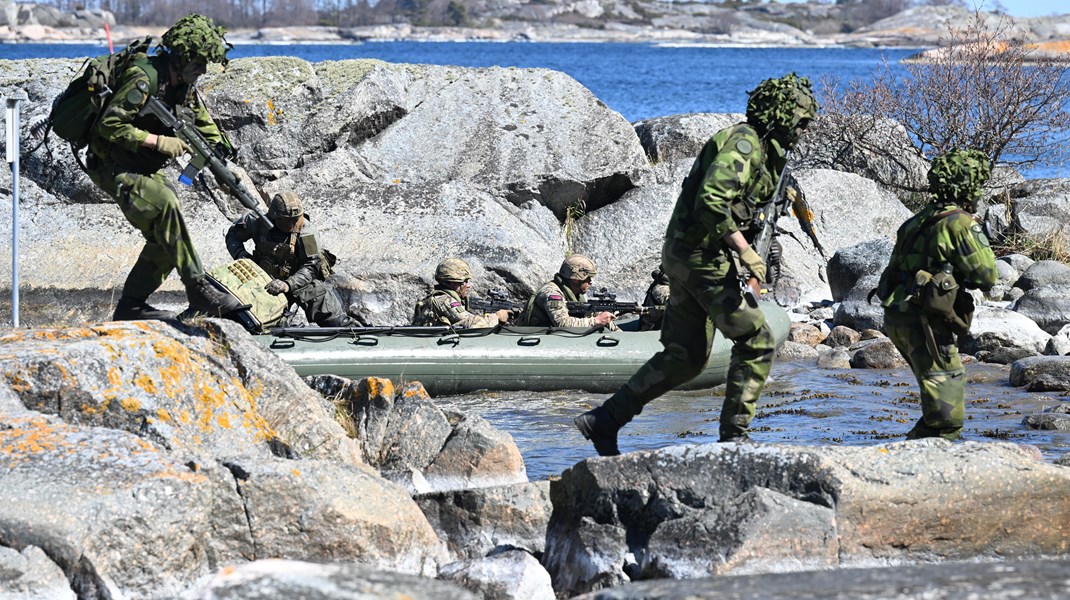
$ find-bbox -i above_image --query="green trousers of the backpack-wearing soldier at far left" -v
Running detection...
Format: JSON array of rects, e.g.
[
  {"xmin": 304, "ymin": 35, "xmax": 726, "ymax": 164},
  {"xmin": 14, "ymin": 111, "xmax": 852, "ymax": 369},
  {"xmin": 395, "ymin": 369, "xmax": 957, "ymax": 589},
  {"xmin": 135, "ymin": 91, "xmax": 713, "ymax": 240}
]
[{"xmin": 89, "ymin": 164, "xmax": 204, "ymax": 301}]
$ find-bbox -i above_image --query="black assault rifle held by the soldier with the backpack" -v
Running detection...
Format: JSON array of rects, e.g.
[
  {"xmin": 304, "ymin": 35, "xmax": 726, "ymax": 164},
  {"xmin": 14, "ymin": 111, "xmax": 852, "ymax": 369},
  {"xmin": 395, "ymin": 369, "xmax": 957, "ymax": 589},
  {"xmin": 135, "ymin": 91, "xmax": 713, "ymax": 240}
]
[{"xmin": 141, "ymin": 96, "xmax": 275, "ymax": 227}]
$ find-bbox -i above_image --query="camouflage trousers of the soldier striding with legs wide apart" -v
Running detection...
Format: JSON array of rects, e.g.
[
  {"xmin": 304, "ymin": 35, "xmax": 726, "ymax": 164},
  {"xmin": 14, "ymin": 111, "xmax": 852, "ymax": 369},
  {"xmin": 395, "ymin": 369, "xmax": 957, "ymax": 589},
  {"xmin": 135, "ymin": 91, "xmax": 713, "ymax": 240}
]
[{"xmin": 605, "ymin": 271, "xmax": 777, "ymax": 439}]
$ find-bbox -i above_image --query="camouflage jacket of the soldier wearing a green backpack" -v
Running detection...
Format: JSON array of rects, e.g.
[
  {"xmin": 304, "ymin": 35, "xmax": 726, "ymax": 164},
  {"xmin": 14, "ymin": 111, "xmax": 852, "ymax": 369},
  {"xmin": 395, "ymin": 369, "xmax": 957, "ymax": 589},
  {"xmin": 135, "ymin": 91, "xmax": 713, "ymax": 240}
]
[{"xmin": 89, "ymin": 56, "xmax": 229, "ymax": 174}]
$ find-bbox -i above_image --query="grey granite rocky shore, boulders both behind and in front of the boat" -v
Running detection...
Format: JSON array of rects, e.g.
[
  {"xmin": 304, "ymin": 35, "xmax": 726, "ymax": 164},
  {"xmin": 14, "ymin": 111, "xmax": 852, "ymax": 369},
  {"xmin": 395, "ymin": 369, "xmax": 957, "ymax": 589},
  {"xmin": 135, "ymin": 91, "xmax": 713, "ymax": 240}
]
[{"xmin": 0, "ymin": 53, "xmax": 1070, "ymax": 599}]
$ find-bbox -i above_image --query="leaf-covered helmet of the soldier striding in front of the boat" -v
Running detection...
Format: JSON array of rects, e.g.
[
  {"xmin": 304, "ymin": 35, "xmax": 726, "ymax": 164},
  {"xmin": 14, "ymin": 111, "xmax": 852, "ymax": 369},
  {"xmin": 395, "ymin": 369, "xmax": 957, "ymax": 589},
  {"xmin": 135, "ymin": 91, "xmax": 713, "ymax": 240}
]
[{"xmin": 747, "ymin": 72, "xmax": 817, "ymax": 144}]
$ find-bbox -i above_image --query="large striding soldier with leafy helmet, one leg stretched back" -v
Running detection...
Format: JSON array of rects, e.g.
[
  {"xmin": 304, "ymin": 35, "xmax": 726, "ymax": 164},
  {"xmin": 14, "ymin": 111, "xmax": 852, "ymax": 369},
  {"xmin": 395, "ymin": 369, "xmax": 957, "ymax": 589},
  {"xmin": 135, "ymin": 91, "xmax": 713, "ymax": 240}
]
[{"xmin": 576, "ymin": 73, "xmax": 817, "ymax": 456}]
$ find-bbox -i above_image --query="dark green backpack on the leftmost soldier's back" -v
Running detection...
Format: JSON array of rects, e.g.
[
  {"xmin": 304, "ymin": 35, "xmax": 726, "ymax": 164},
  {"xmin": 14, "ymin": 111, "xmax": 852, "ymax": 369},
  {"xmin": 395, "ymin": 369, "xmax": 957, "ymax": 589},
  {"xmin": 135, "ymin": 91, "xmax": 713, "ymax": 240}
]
[{"xmin": 46, "ymin": 36, "xmax": 157, "ymax": 149}]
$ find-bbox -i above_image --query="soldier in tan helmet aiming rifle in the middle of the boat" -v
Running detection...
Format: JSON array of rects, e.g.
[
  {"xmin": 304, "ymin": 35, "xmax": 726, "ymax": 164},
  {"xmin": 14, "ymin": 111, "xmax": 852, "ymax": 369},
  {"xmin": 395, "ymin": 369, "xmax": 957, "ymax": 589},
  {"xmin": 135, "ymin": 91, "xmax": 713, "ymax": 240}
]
[{"xmin": 523, "ymin": 255, "xmax": 616, "ymax": 329}]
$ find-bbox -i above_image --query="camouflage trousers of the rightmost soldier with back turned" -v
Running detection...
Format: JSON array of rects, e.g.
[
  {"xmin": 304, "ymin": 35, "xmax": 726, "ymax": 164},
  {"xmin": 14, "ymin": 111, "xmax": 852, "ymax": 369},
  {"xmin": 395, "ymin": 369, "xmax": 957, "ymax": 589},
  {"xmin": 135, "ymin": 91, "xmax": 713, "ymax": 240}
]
[{"xmin": 884, "ymin": 310, "xmax": 966, "ymax": 440}]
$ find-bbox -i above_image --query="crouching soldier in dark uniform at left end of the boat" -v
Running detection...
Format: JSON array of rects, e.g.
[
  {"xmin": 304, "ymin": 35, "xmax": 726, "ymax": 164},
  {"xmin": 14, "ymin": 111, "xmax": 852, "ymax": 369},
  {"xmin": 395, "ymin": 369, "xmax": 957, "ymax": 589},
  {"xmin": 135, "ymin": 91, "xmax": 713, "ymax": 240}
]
[{"xmin": 227, "ymin": 191, "xmax": 355, "ymax": 327}]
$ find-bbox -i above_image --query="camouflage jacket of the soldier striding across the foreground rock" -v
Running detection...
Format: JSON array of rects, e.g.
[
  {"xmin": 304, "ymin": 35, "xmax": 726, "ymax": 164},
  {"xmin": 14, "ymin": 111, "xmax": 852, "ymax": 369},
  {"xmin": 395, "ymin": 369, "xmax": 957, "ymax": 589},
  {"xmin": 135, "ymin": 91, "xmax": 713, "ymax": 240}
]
[{"xmin": 662, "ymin": 123, "xmax": 785, "ymax": 276}]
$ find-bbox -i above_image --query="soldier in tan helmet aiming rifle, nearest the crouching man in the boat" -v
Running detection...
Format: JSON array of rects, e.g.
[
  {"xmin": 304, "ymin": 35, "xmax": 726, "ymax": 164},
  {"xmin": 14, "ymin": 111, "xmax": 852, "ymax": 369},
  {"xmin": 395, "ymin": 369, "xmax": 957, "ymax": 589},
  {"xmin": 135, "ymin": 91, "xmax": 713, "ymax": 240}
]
[{"xmin": 412, "ymin": 259, "xmax": 509, "ymax": 329}]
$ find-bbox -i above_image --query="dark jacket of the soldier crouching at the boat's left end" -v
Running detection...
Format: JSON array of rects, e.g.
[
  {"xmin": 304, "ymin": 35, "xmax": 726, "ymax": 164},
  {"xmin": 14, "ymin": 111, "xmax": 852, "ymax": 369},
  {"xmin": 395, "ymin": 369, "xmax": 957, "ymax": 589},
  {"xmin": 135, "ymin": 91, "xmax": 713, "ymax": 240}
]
[{"xmin": 227, "ymin": 212, "xmax": 326, "ymax": 291}]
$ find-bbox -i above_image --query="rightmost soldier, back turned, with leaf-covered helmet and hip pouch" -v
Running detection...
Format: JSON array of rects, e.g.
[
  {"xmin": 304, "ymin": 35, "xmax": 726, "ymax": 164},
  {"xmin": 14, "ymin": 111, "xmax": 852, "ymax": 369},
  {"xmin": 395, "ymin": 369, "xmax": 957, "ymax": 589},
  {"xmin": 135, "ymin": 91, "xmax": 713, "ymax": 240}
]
[{"xmin": 876, "ymin": 150, "xmax": 998, "ymax": 440}]
